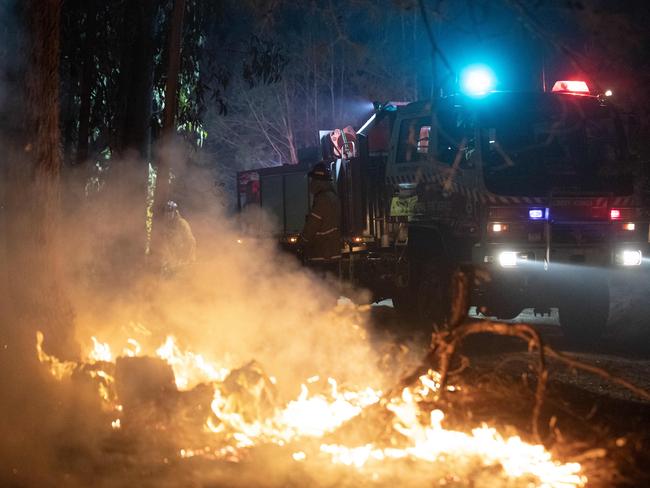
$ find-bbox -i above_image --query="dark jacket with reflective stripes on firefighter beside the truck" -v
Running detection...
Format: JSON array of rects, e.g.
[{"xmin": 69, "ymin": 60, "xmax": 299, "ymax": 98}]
[{"xmin": 300, "ymin": 180, "xmax": 341, "ymax": 261}]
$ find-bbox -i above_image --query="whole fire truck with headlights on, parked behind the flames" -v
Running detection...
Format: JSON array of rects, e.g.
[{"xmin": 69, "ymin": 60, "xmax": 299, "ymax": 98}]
[{"xmin": 238, "ymin": 81, "xmax": 650, "ymax": 343}]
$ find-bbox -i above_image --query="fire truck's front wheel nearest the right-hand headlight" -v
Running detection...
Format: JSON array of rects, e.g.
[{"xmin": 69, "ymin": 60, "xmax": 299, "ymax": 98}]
[{"xmin": 559, "ymin": 277, "xmax": 609, "ymax": 346}]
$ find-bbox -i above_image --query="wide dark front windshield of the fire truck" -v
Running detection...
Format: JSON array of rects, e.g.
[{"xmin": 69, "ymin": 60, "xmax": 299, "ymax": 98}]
[{"xmin": 479, "ymin": 94, "xmax": 633, "ymax": 196}]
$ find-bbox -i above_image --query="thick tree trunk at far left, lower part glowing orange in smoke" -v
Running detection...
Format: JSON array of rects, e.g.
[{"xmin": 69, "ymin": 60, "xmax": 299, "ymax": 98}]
[{"xmin": 3, "ymin": 0, "xmax": 74, "ymax": 357}]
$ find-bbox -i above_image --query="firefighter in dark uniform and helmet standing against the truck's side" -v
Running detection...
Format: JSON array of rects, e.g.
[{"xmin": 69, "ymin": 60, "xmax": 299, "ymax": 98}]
[{"xmin": 299, "ymin": 162, "xmax": 341, "ymax": 275}]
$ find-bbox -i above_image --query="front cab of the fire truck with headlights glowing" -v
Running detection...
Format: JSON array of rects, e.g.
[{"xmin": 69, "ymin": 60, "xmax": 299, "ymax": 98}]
[{"xmin": 386, "ymin": 85, "xmax": 649, "ymax": 341}]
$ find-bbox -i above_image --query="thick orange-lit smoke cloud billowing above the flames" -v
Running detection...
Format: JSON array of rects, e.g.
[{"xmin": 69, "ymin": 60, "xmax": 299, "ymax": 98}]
[{"xmin": 64, "ymin": 154, "xmax": 388, "ymax": 394}]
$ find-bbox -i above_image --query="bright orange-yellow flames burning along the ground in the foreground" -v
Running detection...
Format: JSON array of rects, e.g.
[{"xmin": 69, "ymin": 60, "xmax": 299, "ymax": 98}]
[{"xmin": 36, "ymin": 332, "xmax": 587, "ymax": 488}]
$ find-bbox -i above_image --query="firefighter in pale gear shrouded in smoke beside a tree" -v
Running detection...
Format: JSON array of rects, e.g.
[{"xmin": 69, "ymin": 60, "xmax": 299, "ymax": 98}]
[{"xmin": 161, "ymin": 201, "xmax": 196, "ymax": 274}]
